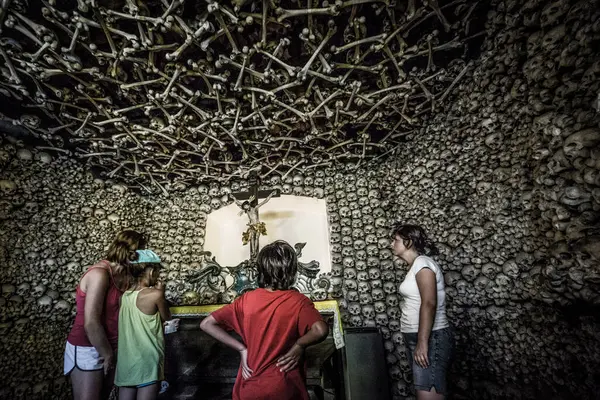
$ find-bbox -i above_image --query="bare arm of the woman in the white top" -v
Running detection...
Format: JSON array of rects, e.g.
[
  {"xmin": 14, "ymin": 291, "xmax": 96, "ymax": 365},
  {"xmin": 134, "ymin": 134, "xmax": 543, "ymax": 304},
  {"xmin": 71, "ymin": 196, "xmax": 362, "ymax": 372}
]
[{"xmin": 415, "ymin": 268, "xmax": 437, "ymax": 368}]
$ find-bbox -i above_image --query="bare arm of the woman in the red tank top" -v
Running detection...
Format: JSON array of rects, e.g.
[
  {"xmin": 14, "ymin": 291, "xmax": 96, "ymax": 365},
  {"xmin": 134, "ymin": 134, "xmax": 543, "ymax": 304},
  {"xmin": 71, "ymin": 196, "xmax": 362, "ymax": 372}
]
[{"xmin": 83, "ymin": 268, "xmax": 114, "ymax": 373}]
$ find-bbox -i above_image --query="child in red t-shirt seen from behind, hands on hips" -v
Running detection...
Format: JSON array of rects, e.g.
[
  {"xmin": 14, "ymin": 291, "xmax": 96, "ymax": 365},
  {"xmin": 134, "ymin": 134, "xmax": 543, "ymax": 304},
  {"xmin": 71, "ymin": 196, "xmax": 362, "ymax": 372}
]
[{"xmin": 200, "ymin": 240, "xmax": 329, "ymax": 400}]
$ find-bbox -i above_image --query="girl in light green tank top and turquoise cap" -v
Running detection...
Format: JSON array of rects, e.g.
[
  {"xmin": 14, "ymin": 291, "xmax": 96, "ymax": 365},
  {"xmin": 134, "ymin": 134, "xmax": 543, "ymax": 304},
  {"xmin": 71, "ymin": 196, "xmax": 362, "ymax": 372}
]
[{"xmin": 115, "ymin": 250, "xmax": 177, "ymax": 400}]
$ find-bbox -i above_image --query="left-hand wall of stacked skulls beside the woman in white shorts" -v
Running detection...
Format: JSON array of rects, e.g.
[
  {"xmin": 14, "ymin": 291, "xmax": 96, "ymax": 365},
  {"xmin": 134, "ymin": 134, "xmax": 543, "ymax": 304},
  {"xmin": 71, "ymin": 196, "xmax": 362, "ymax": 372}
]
[{"xmin": 0, "ymin": 138, "xmax": 148, "ymax": 400}]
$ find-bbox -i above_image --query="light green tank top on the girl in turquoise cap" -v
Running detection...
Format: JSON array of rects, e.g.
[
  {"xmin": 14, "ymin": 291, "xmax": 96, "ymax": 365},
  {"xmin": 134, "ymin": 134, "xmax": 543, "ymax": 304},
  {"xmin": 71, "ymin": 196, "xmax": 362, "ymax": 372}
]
[{"xmin": 115, "ymin": 289, "xmax": 165, "ymax": 386}]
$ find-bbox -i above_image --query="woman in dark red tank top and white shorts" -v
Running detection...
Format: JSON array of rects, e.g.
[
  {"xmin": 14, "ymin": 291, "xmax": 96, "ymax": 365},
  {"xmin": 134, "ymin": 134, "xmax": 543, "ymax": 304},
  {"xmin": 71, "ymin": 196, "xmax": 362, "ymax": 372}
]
[{"xmin": 64, "ymin": 230, "xmax": 143, "ymax": 400}]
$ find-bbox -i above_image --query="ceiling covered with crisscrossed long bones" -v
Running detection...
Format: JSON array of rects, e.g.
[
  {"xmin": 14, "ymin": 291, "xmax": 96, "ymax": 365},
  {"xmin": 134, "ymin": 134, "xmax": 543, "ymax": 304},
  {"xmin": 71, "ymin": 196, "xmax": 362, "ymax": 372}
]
[{"xmin": 0, "ymin": 0, "xmax": 485, "ymax": 191}]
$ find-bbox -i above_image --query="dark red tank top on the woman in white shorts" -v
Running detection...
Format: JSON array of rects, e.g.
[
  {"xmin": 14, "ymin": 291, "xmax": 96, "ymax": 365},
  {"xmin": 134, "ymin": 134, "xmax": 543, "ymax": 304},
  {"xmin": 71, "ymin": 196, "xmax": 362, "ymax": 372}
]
[{"xmin": 67, "ymin": 260, "xmax": 123, "ymax": 349}]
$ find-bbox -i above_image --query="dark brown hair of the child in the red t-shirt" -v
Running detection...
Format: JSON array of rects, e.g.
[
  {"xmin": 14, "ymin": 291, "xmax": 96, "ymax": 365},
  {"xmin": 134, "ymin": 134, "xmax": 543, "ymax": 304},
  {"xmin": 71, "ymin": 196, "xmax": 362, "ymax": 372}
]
[{"xmin": 256, "ymin": 240, "xmax": 298, "ymax": 290}]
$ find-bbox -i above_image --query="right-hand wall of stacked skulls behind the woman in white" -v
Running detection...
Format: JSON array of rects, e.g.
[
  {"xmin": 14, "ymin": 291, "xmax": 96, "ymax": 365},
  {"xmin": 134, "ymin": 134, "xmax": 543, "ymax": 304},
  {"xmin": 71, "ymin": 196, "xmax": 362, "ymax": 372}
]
[{"xmin": 380, "ymin": 1, "xmax": 600, "ymax": 399}]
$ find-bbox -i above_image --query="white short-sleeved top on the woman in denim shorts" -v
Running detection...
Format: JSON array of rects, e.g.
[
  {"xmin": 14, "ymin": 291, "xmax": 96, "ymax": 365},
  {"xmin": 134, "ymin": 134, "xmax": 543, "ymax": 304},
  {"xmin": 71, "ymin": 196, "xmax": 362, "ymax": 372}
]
[{"xmin": 399, "ymin": 256, "xmax": 448, "ymax": 333}]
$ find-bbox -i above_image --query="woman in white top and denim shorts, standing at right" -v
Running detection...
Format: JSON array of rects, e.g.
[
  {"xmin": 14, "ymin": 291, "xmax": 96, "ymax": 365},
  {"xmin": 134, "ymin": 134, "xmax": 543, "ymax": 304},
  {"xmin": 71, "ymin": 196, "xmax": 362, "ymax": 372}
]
[{"xmin": 392, "ymin": 224, "xmax": 454, "ymax": 400}]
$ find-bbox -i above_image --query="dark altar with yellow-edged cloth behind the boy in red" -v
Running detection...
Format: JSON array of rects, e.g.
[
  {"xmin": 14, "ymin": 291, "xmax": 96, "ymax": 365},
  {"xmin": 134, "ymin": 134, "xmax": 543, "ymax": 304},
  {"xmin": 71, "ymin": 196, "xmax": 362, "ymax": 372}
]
[{"xmin": 159, "ymin": 300, "xmax": 344, "ymax": 400}]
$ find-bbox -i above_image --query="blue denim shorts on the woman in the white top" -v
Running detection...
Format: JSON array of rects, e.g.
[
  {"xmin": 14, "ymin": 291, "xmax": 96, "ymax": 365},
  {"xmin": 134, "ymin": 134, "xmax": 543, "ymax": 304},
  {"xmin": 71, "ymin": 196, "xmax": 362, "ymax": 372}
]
[{"xmin": 403, "ymin": 327, "xmax": 454, "ymax": 394}]
